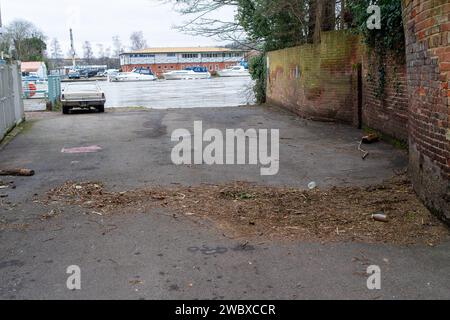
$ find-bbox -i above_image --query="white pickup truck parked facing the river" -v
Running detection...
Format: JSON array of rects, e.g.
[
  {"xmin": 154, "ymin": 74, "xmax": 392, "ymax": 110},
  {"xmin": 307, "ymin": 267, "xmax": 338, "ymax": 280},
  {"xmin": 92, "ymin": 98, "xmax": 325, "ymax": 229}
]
[{"xmin": 61, "ymin": 83, "xmax": 106, "ymax": 114}]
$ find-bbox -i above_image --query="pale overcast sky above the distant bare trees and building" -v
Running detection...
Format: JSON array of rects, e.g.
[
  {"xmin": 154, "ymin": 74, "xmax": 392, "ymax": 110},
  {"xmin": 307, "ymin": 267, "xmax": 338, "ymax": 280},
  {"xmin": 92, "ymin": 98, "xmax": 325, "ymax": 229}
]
[{"xmin": 0, "ymin": 0, "xmax": 234, "ymax": 55}]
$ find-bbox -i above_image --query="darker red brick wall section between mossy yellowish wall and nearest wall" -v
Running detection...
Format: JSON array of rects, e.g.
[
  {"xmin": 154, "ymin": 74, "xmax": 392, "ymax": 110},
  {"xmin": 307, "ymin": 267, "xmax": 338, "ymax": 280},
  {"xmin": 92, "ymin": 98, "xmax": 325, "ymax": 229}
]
[{"xmin": 362, "ymin": 53, "xmax": 409, "ymax": 141}]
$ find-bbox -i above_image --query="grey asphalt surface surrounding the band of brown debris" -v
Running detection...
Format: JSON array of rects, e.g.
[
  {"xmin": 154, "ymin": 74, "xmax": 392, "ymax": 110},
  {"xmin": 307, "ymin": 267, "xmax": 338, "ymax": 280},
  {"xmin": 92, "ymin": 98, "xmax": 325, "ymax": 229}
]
[{"xmin": 0, "ymin": 107, "xmax": 450, "ymax": 299}]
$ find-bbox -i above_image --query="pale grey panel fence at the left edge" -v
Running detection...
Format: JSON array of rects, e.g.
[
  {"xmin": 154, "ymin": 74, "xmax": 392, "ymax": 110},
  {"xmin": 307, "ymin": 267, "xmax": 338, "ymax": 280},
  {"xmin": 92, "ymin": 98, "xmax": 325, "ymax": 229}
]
[{"xmin": 0, "ymin": 63, "xmax": 24, "ymax": 140}]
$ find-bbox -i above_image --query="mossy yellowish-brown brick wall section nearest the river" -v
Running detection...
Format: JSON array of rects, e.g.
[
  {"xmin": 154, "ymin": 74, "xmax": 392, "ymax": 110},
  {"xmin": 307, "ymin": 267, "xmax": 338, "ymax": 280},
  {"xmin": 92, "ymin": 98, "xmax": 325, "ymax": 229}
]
[{"xmin": 267, "ymin": 31, "xmax": 360, "ymax": 123}]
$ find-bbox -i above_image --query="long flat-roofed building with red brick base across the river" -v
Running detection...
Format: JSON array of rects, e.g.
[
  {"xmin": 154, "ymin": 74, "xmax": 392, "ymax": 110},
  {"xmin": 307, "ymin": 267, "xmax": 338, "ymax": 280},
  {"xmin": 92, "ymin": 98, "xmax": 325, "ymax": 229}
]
[{"xmin": 120, "ymin": 47, "xmax": 247, "ymax": 76}]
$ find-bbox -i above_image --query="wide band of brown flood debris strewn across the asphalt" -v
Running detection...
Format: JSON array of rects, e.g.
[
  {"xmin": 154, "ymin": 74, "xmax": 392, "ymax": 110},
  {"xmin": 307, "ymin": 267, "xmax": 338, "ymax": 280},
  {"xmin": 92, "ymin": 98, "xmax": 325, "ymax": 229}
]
[{"xmin": 46, "ymin": 176, "xmax": 449, "ymax": 245}]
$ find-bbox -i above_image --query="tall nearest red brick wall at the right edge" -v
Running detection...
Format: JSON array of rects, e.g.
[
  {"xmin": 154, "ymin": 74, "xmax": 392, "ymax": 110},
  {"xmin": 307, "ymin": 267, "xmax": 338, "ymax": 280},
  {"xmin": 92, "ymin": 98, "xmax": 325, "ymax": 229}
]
[{"xmin": 403, "ymin": 0, "xmax": 450, "ymax": 221}]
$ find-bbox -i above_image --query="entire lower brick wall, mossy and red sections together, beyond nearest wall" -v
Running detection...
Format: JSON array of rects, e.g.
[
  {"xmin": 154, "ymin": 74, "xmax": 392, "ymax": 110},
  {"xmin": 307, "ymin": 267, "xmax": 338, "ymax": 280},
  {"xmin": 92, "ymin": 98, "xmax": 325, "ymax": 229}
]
[{"xmin": 267, "ymin": 31, "xmax": 408, "ymax": 141}]
